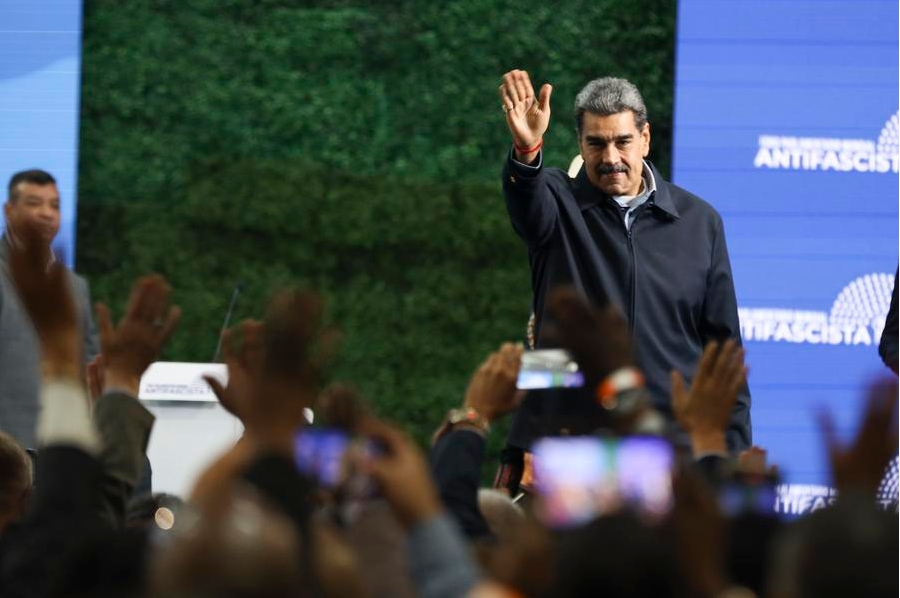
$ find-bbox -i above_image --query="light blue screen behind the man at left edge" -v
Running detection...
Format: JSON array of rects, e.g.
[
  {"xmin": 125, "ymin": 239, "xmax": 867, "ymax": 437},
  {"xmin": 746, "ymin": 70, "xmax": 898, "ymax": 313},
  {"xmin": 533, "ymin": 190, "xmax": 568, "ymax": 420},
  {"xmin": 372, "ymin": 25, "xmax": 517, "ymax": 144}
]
[{"xmin": 0, "ymin": 0, "xmax": 81, "ymax": 266}]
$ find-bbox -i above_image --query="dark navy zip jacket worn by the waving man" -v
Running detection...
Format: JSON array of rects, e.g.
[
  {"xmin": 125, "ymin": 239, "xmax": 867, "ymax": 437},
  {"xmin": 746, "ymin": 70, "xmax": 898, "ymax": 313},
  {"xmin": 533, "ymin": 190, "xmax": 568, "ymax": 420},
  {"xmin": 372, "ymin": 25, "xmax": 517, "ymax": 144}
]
[{"xmin": 503, "ymin": 157, "xmax": 752, "ymax": 451}]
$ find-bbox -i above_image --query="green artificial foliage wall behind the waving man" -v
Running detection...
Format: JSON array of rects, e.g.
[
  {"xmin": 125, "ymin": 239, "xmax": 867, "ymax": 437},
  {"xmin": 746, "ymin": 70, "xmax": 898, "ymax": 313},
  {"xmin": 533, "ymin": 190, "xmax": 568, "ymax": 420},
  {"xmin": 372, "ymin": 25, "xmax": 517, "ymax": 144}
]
[{"xmin": 78, "ymin": 0, "xmax": 675, "ymax": 468}]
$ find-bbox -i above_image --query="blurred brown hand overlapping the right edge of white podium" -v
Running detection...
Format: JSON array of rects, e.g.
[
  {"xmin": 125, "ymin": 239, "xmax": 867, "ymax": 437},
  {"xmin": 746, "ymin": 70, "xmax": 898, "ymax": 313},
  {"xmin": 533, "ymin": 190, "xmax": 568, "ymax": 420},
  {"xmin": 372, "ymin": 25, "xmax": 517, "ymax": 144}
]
[{"xmin": 203, "ymin": 320, "xmax": 265, "ymax": 421}]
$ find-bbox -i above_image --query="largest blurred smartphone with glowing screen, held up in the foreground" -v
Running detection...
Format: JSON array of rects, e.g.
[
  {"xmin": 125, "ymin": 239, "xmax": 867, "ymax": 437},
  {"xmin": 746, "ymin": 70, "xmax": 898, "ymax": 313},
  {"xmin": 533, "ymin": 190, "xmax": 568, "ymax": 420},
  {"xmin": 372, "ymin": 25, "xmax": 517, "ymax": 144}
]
[{"xmin": 532, "ymin": 436, "xmax": 673, "ymax": 528}]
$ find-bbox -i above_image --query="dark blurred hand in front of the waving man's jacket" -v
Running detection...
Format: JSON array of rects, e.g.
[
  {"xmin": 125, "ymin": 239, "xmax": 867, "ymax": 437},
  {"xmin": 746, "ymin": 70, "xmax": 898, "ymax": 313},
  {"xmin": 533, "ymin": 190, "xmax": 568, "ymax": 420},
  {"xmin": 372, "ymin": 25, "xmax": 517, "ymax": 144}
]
[{"xmin": 542, "ymin": 287, "xmax": 634, "ymax": 390}]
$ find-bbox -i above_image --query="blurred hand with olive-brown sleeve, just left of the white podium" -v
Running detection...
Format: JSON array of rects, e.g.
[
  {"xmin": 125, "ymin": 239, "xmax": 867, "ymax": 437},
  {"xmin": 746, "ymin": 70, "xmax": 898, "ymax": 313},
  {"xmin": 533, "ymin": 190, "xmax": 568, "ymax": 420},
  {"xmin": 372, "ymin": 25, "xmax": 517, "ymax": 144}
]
[{"xmin": 95, "ymin": 274, "xmax": 181, "ymax": 396}]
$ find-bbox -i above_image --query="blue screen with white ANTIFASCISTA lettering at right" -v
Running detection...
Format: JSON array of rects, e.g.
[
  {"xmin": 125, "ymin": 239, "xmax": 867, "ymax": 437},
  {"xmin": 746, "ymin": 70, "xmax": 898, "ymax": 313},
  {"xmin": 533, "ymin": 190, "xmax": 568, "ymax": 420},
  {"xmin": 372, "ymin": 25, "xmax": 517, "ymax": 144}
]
[{"xmin": 673, "ymin": 0, "xmax": 900, "ymax": 514}]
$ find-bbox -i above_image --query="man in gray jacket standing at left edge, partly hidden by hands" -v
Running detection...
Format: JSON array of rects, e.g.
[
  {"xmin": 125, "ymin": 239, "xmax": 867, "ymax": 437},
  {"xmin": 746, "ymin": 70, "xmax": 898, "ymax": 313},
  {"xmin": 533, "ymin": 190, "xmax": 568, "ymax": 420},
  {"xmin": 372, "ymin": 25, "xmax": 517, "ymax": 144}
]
[{"xmin": 0, "ymin": 170, "xmax": 99, "ymax": 447}]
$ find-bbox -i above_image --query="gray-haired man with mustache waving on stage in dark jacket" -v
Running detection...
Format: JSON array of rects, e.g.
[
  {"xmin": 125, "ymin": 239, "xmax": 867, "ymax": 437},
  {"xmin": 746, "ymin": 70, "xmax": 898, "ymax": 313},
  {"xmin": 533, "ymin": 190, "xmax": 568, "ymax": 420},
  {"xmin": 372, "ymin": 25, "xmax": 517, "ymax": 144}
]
[{"xmin": 499, "ymin": 70, "xmax": 751, "ymax": 478}]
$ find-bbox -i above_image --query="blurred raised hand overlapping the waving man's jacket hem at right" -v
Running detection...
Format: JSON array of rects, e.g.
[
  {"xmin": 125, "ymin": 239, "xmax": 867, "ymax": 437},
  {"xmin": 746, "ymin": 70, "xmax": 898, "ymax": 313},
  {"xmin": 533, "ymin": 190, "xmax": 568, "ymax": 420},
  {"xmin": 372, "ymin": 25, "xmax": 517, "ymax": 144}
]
[{"xmin": 671, "ymin": 340, "xmax": 747, "ymax": 454}]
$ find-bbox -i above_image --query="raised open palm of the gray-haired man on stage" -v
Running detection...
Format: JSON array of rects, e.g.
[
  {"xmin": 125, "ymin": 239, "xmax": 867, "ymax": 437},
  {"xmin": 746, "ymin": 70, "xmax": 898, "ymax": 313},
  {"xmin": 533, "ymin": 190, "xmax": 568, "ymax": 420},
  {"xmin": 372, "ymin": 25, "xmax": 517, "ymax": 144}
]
[{"xmin": 499, "ymin": 70, "xmax": 553, "ymax": 163}]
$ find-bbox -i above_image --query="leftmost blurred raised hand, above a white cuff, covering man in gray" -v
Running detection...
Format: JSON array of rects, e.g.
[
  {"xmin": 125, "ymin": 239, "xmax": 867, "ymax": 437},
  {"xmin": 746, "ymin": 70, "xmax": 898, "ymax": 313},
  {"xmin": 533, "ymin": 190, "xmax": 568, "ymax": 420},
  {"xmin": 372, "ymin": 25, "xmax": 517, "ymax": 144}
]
[{"xmin": 9, "ymin": 224, "xmax": 82, "ymax": 379}]
